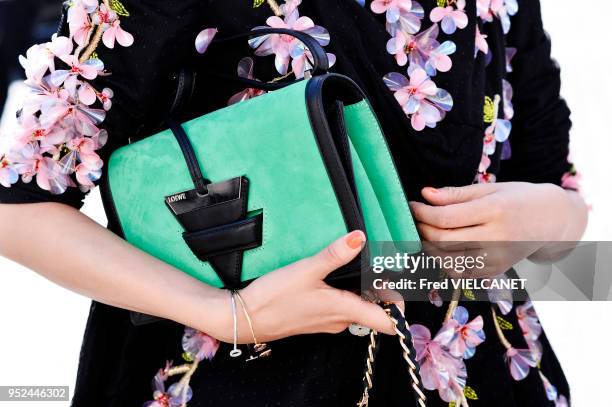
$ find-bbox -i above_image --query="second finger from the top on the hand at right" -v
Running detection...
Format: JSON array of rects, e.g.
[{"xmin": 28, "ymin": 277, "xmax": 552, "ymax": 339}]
[{"xmin": 410, "ymin": 199, "xmax": 494, "ymax": 229}]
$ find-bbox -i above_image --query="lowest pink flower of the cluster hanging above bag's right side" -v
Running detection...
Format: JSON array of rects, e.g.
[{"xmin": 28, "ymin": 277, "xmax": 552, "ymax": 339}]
[{"xmin": 383, "ymin": 68, "xmax": 453, "ymax": 131}]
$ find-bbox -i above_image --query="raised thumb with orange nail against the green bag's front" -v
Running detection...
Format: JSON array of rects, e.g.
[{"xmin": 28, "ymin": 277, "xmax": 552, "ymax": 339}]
[{"xmin": 311, "ymin": 230, "xmax": 366, "ymax": 278}]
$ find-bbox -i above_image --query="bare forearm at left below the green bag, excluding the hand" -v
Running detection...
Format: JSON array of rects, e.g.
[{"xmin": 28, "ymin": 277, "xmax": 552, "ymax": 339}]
[{"xmin": 0, "ymin": 203, "xmax": 224, "ymax": 329}]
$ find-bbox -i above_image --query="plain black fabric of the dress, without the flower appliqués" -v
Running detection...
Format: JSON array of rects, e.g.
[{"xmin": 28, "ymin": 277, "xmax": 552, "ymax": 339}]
[{"xmin": 0, "ymin": 0, "xmax": 571, "ymax": 407}]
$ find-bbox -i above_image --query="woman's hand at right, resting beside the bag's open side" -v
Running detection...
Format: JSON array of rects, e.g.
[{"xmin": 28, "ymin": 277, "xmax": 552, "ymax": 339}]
[{"xmin": 411, "ymin": 182, "xmax": 587, "ymax": 277}]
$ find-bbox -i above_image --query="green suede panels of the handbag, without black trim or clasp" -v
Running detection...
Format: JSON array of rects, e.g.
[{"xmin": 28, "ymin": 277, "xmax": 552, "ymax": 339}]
[{"xmin": 108, "ymin": 81, "xmax": 418, "ymax": 287}]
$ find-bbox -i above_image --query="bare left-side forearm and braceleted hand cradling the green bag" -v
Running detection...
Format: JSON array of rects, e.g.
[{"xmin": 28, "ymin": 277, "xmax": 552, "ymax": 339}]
[{"xmin": 0, "ymin": 203, "xmax": 394, "ymax": 343}]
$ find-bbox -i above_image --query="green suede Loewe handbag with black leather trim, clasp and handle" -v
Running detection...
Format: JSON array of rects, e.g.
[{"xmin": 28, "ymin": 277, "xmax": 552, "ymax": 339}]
[{"xmin": 104, "ymin": 29, "xmax": 420, "ymax": 308}]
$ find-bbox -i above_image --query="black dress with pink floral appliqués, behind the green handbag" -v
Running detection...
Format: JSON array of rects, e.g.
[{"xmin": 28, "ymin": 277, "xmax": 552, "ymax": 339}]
[{"xmin": 0, "ymin": 0, "xmax": 578, "ymax": 407}]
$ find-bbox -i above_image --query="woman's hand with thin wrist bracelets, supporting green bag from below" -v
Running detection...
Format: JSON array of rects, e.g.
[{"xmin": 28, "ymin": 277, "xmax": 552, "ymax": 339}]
[{"xmin": 195, "ymin": 231, "xmax": 403, "ymax": 343}]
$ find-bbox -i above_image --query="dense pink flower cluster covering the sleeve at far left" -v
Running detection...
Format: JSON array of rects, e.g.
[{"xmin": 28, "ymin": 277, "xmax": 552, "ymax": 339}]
[{"xmin": 0, "ymin": 0, "xmax": 133, "ymax": 194}]
